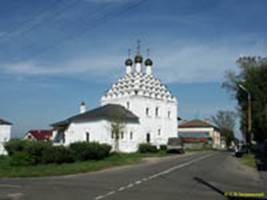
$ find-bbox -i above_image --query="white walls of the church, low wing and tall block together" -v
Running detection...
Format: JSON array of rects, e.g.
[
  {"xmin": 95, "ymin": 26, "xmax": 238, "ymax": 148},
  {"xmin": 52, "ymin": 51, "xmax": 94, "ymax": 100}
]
[{"xmin": 53, "ymin": 93, "xmax": 177, "ymax": 152}]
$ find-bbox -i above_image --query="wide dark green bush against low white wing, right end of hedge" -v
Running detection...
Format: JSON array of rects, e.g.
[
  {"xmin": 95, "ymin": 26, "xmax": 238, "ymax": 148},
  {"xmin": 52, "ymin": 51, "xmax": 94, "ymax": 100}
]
[{"xmin": 70, "ymin": 142, "xmax": 111, "ymax": 161}]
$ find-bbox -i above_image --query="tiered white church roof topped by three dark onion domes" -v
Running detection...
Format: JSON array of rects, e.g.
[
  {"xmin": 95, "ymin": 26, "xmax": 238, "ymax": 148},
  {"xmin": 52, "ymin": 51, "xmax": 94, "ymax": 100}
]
[{"xmin": 102, "ymin": 43, "xmax": 176, "ymax": 102}]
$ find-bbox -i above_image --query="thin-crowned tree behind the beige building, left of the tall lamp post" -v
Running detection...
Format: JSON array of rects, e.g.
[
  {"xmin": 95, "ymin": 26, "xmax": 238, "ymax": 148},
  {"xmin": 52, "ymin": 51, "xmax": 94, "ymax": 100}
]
[{"xmin": 210, "ymin": 111, "xmax": 236, "ymax": 147}]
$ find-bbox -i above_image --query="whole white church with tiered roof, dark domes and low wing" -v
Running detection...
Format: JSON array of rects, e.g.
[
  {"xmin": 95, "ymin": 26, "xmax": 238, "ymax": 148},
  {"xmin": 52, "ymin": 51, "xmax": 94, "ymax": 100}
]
[{"xmin": 52, "ymin": 46, "xmax": 178, "ymax": 152}]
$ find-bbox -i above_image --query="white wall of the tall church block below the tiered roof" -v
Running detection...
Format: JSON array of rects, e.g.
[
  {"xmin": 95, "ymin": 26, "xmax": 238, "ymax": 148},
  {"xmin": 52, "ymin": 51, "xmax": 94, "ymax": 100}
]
[{"xmin": 101, "ymin": 96, "xmax": 177, "ymax": 150}]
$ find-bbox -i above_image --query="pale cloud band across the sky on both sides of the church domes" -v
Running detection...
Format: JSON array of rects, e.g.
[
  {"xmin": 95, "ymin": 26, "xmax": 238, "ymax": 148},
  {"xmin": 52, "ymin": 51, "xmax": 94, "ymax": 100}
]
[{"xmin": 0, "ymin": 36, "xmax": 267, "ymax": 82}]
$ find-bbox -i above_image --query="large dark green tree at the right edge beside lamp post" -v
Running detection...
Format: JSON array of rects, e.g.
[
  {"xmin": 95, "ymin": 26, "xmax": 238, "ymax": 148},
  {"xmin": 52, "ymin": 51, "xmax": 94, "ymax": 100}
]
[{"xmin": 223, "ymin": 57, "xmax": 267, "ymax": 142}]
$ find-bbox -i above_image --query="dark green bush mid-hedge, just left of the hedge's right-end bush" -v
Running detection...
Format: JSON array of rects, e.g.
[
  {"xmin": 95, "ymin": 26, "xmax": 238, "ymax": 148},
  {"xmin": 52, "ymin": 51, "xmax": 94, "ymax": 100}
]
[{"xmin": 42, "ymin": 146, "xmax": 74, "ymax": 164}]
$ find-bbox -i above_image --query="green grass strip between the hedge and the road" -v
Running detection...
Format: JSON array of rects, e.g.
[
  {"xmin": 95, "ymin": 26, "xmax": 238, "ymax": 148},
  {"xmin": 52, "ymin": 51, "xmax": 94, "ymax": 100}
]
[{"xmin": 0, "ymin": 151, "xmax": 168, "ymax": 177}]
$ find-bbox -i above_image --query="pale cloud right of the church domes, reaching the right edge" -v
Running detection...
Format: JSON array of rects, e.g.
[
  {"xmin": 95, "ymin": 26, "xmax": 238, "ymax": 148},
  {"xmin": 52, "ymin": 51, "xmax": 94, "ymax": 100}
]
[{"xmin": 154, "ymin": 39, "xmax": 267, "ymax": 82}]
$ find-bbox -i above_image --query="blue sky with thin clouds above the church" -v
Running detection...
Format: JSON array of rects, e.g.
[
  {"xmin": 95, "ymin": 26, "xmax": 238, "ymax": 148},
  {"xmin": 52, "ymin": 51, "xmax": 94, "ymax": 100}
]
[{"xmin": 0, "ymin": 0, "xmax": 267, "ymax": 138}]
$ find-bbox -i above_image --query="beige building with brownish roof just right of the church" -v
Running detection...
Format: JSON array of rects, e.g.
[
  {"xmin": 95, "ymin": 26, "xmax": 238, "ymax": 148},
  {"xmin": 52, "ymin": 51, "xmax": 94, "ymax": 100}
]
[{"xmin": 178, "ymin": 119, "xmax": 222, "ymax": 149}]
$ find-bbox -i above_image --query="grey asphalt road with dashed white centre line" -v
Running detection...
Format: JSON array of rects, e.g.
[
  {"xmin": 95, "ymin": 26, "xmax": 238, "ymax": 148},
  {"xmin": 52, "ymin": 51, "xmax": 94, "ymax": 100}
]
[{"xmin": 0, "ymin": 152, "xmax": 267, "ymax": 200}]
